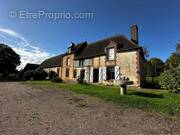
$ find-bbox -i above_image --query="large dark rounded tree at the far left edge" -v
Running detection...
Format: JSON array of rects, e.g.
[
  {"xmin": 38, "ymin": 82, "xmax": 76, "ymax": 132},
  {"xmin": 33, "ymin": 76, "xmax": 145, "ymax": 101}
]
[{"xmin": 0, "ymin": 44, "xmax": 21, "ymax": 76}]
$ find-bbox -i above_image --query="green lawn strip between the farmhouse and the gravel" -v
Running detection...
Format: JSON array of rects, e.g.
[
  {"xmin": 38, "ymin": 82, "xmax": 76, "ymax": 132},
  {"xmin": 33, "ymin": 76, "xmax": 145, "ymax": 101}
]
[{"xmin": 26, "ymin": 81, "xmax": 180, "ymax": 116}]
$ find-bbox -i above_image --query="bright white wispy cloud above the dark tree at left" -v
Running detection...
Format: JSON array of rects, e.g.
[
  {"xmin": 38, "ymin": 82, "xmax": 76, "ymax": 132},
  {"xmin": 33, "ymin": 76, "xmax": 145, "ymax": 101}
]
[{"xmin": 0, "ymin": 28, "xmax": 53, "ymax": 69}]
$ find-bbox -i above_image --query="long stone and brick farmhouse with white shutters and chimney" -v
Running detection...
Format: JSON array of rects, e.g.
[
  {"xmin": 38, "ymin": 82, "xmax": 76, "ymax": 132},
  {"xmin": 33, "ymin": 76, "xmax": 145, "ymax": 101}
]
[{"xmin": 40, "ymin": 25, "xmax": 144, "ymax": 87}]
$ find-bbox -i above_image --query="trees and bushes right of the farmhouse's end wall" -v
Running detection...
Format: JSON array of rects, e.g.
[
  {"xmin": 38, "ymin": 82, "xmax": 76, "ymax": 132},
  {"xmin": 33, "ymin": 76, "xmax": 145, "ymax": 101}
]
[{"xmin": 144, "ymin": 43, "xmax": 180, "ymax": 90}]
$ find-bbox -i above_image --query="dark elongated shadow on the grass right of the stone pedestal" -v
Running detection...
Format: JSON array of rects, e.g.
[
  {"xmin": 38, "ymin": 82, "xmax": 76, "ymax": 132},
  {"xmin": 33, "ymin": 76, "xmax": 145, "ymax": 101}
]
[{"xmin": 129, "ymin": 92, "xmax": 164, "ymax": 98}]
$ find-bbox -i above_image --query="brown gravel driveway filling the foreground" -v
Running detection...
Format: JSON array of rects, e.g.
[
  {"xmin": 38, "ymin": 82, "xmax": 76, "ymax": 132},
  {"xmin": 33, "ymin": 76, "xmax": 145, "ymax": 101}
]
[{"xmin": 0, "ymin": 82, "xmax": 180, "ymax": 135}]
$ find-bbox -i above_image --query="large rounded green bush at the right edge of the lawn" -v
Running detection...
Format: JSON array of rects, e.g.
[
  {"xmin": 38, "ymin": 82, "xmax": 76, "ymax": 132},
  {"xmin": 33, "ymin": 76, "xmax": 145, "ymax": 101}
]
[{"xmin": 159, "ymin": 69, "xmax": 180, "ymax": 92}]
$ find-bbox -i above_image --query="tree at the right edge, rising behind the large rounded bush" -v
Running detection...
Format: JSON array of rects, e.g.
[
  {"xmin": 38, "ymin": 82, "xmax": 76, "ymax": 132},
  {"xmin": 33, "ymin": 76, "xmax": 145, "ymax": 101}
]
[{"xmin": 166, "ymin": 43, "xmax": 180, "ymax": 69}]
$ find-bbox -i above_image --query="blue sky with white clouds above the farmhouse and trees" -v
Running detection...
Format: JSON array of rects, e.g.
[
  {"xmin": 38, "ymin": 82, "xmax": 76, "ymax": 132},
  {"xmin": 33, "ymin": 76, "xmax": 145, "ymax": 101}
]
[{"xmin": 0, "ymin": 0, "xmax": 180, "ymax": 69}]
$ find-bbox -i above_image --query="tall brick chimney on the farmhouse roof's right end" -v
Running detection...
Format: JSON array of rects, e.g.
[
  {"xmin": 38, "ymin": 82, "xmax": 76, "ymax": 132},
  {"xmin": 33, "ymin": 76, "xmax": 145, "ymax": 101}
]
[{"xmin": 131, "ymin": 25, "xmax": 139, "ymax": 44}]
